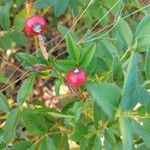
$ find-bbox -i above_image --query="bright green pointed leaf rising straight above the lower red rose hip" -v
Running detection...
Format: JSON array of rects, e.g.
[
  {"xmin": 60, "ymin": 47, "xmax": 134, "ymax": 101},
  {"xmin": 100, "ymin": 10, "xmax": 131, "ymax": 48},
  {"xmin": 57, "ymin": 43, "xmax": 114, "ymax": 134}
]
[{"xmin": 66, "ymin": 34, "xmax": 80, "ymax": 62}]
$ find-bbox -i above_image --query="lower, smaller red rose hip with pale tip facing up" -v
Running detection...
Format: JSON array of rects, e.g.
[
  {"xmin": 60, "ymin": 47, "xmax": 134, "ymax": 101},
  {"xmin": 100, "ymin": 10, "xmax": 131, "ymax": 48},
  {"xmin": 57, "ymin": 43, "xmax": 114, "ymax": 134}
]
[{"xmin": 66, "ymin": 68, "xmax": 87, "ymax": 86}]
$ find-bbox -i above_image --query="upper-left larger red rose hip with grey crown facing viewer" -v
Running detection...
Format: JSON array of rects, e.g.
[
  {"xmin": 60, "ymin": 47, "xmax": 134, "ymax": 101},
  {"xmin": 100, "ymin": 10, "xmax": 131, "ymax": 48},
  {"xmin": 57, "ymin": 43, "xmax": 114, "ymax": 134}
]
[{"xmin": 24, "ymin": 16, "xmax": 47, "ymax": 36}]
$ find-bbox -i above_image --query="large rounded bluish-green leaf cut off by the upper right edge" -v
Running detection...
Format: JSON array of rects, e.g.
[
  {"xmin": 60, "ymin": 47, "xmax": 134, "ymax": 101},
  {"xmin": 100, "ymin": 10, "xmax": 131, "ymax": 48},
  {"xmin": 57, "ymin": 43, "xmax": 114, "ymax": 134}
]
[{"xmin": 136, "ymin": 15, "xmax": 150, "ymax": 51}]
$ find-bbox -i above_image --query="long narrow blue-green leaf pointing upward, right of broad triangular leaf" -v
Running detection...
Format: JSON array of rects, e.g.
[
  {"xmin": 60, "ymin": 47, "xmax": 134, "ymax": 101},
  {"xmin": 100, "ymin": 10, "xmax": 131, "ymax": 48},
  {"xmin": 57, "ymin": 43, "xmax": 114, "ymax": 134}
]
[{"xmin": 121, "ymin": 52, "xmax": 138, "ymax": 110}]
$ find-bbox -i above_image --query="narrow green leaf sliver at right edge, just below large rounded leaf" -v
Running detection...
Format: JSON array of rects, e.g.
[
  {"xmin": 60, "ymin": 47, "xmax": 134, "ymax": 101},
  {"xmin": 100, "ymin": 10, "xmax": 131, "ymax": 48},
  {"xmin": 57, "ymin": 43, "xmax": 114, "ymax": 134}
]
[{"xmin": 145, "ymin": 46, "xmax": 150, "ymax": 80}]
